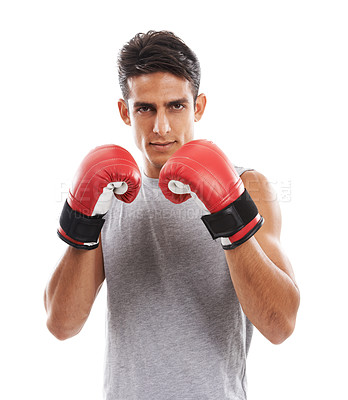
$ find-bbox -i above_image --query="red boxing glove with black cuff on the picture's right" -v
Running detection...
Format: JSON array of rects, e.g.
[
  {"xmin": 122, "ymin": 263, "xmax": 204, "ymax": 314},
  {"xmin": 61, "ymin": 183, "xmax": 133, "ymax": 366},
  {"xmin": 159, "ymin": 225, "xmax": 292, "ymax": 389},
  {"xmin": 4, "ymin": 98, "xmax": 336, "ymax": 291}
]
[{"xmin": 159, "ymin": 140, "xmax": 263, "ymax": 250}]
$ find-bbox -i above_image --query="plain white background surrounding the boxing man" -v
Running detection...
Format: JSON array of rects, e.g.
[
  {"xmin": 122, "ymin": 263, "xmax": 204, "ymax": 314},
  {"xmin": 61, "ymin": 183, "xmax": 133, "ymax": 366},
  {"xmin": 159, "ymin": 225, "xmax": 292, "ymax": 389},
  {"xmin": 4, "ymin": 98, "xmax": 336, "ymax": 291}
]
[{"xmin": 0, "ymin": 0, "xmax": 348, "ymax": 400}]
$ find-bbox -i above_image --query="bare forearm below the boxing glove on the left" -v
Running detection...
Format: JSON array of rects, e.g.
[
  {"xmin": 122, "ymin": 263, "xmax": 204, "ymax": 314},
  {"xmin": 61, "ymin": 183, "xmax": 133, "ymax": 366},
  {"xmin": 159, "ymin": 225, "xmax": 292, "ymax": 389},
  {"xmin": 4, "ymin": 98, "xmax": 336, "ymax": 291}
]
[{"xmin": 44, "ymin": 241, "xmax": 105, "ymax": 340}]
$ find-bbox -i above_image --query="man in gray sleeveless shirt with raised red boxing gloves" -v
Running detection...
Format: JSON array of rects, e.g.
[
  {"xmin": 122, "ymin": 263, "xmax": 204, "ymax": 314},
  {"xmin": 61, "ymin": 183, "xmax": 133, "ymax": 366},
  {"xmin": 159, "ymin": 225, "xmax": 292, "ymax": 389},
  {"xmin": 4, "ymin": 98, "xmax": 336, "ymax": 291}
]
[{"xmin": 45, "ymin": 31, "xmax": 299, "ymax": 400}]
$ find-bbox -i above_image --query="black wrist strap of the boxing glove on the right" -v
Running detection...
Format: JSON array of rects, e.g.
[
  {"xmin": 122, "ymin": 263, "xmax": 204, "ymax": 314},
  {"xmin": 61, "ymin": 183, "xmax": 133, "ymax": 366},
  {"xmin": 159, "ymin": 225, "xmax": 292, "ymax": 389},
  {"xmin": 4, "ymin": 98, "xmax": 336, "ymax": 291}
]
[{"xmin": 201, "ymin": 189, "xmax": 259, "ymax": 239}]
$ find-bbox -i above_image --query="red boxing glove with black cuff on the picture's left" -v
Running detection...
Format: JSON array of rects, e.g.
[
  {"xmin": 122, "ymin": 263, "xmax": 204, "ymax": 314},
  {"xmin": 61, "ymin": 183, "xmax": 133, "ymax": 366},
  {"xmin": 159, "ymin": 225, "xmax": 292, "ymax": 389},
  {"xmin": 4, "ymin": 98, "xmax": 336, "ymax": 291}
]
[{"xmin": 58, "ymin": 144, "xmax": 141, "ymax": 250}]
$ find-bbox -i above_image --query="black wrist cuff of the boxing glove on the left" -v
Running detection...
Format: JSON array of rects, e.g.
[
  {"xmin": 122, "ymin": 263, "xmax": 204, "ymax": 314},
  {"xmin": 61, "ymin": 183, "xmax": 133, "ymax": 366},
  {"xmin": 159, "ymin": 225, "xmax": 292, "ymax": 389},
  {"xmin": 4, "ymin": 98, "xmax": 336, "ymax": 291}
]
[{"xmin": 58, "ymin": 201, "xmax": 105, "ymax": 249}]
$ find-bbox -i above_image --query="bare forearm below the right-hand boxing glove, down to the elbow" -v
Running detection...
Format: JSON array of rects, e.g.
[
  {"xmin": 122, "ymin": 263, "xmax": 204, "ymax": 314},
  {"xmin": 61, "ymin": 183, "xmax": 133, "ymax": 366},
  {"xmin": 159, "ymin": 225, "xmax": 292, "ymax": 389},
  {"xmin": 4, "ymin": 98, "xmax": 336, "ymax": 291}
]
[{"xmin": 225, "ymin": 237, "xmax": 300, "ymax": 344}]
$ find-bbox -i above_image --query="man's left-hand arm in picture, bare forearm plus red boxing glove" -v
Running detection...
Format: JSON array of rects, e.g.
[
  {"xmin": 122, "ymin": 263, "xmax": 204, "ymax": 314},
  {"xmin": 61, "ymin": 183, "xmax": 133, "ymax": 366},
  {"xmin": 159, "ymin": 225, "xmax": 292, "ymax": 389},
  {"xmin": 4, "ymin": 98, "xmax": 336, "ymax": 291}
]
[{"xmin": 44, "ymin": 145, "xmax": 141, "ymax": 340}]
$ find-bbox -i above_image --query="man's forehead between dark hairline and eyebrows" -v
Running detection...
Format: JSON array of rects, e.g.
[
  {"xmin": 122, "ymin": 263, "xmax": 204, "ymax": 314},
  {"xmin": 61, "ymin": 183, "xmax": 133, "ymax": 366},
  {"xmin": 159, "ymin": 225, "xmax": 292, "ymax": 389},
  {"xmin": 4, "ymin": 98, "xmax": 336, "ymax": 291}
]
[{"xmin": 127, "ymin": 72, "xmax": 193, "ymax": 102}]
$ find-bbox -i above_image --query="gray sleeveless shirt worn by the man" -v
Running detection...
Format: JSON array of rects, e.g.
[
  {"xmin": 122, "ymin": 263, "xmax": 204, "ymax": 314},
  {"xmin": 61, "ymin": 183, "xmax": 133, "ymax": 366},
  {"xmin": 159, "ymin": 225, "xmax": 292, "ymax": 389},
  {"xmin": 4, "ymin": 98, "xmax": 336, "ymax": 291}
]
[{"xmin": 102, "ymin": 168, "xmax": 253, "ymax": 400}]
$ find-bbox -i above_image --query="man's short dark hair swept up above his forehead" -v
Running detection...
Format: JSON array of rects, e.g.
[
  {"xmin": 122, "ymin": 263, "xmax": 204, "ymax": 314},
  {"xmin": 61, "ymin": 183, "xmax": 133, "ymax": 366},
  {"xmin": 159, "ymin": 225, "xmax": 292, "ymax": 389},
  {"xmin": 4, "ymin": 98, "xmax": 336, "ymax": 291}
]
[{"xmin": 117, "ymin": 31, "xmax": 201, "ymax": 101}]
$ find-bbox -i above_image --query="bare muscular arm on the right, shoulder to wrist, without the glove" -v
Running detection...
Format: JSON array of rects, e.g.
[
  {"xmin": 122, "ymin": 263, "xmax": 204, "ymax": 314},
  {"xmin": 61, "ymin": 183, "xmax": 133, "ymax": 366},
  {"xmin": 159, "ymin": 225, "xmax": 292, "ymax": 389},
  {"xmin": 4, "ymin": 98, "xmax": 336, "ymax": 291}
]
[{"xmin": 225, "ymin": 171, "xmax": 300, "ymax": 344}]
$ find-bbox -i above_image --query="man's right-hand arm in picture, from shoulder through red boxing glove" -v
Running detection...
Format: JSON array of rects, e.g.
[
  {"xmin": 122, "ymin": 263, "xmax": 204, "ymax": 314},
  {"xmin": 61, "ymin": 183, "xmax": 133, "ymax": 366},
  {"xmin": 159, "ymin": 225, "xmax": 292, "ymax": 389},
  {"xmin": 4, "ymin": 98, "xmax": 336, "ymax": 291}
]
[{"xmin": 159, "ymin": 139, "xmax": 300, "ymax": 343}]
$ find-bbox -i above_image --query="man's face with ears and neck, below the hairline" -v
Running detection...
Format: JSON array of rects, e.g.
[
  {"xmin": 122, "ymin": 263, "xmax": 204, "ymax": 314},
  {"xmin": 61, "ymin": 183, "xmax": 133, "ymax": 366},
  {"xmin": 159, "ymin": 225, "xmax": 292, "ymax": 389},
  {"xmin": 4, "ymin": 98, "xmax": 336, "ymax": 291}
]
[{"xmin": 118, "ymin": 72, "xmax": 206, "ymax": 178}]
